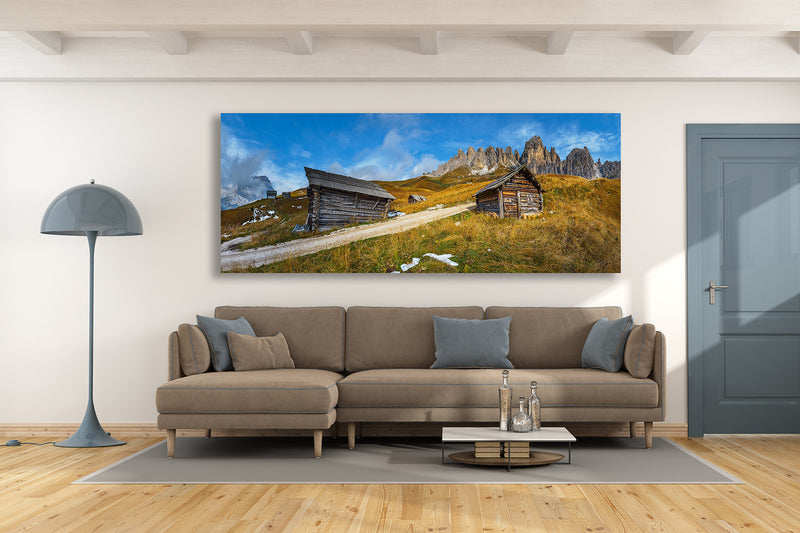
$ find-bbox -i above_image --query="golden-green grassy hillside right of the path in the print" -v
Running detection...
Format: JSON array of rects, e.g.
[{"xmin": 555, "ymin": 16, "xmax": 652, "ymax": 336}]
[{"xmin": 230, "ymin": 175, "xmax": 620, "ymax": 273}]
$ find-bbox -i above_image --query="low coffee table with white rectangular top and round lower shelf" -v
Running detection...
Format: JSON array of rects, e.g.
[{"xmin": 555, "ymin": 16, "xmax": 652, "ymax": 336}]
[{"xmin": 442, "ymin": 427, "xmax": 577, "ymax": 471}]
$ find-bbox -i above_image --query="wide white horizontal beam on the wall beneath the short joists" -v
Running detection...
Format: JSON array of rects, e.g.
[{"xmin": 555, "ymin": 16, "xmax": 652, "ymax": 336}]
[{"xmin": 0, "ymin": 33, "xmax": 800, "ymax": 82}]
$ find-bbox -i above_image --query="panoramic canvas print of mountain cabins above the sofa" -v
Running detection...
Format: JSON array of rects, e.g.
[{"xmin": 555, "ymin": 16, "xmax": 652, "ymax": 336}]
[{"xmin": 220, "ymin": 113, "xmax": 621, "ymax": 275}]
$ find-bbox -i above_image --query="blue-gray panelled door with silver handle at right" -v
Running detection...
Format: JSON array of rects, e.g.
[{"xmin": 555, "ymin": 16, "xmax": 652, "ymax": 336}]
[{"xmin": 686, "ymin": 124, "xmax": 800, "ymax": 436}]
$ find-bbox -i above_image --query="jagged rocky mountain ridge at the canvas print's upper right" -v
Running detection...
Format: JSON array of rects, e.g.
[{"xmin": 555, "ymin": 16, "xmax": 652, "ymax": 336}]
[{"xmin": 431, "ymin": 135, "xmax": 620, "ymax": 179}]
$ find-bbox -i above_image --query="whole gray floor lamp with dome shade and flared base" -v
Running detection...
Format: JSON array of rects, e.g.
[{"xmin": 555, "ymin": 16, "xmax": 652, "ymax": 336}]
[{"xmin": 41, "ymin": 180, "xmax": 142, "ymax": 448}]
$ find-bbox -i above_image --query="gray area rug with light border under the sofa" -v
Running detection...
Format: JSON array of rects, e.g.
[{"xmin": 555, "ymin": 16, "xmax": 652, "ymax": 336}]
[{"xmin": 75, "ymin": 437, "xmax": 741, "ymax": 484}]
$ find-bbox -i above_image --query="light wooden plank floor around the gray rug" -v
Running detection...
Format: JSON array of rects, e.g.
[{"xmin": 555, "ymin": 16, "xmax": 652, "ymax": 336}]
[{"xmin": 0, "ymin": 435, "xmax": 800, "ymax": 533}]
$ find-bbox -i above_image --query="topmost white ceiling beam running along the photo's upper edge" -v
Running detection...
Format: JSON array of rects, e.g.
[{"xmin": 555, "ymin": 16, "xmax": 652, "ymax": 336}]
[{"xmin": 0, "ymin": 0, "xmax": 800, "ymax": 31}]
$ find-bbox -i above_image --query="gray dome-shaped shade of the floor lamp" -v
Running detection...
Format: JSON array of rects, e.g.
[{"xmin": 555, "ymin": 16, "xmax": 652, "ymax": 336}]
[{"xmin": 41, "ymin": 183, "xmax": 142, "ymax": 237}]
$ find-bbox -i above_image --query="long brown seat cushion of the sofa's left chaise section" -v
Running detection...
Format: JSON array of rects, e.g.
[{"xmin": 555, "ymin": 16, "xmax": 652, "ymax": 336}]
[{"xmin": 156, "ymin": 368, "xmax": 342, "ymax": 414}]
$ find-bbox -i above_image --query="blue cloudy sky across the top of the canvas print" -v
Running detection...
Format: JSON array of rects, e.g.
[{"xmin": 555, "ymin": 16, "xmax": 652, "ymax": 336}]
[{"xmin": 220, "ymin": 113, "xmax": 620, "ymax": 201}]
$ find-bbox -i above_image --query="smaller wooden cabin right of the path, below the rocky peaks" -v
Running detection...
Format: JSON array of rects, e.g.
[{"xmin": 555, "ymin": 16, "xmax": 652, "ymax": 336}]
[{"xmin": 474, "ymin": 165, "xmax": 544, "ymax": 218}]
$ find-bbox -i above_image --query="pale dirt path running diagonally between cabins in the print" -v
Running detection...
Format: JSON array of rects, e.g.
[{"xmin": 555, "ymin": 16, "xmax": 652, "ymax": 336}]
[{"xmin": 220, "ymin": 203, "xmax": 475, "ymax": 271}]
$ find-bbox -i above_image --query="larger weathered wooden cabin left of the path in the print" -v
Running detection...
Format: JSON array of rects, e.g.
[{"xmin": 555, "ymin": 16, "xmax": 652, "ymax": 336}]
[{"xmin": 305, "ymin": 167, "xmax": 395, "ymax": 231}]
